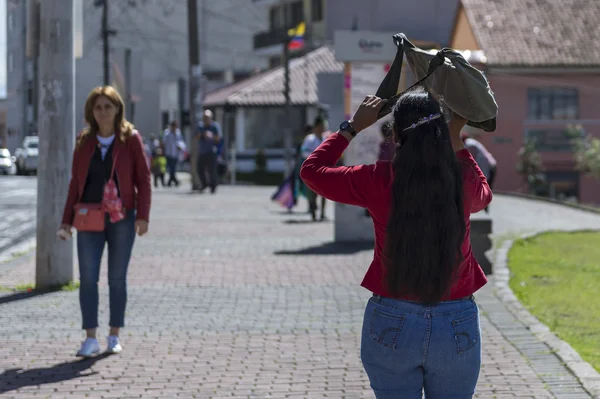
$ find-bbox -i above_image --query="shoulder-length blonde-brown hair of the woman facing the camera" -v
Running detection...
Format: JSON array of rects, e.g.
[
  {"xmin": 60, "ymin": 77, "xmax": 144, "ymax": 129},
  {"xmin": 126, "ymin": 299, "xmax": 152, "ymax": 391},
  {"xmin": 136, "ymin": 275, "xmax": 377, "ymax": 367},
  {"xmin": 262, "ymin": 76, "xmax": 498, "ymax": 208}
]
[{"xmin": 77, "ymin": 86, "xmax": 134, "ymax": 148}]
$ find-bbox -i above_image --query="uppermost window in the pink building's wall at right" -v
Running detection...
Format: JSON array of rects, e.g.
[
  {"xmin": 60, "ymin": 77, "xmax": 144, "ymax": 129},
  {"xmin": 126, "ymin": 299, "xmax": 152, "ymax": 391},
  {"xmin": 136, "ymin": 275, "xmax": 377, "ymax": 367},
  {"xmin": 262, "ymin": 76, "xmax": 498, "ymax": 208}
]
[{"xmin": 528, "ymin": 87, "xmax": 579, "ymax": 120}]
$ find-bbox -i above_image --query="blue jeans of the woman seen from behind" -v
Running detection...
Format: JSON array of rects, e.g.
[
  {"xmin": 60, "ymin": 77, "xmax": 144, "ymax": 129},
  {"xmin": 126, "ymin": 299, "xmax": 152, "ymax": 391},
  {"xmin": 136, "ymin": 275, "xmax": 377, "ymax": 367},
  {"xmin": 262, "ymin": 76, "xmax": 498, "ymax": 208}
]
[{"xmin": 361, "ymin": 295, "xmax": 481, "ymax": 399}]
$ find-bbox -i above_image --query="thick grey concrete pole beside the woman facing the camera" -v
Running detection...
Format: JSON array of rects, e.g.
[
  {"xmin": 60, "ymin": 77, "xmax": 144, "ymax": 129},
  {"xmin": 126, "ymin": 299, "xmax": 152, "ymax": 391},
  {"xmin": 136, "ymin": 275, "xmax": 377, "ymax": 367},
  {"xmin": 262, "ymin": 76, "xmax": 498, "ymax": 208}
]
[{"xmin": 35, "ymin": 0, "xmax": 75, "ymax": 289}]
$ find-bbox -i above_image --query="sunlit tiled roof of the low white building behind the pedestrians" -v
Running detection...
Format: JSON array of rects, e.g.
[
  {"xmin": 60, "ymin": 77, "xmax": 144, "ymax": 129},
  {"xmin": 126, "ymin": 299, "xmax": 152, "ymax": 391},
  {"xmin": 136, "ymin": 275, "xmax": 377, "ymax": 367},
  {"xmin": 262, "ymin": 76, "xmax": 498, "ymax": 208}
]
[{"xmin": 204, "ymin": 46, "xmax": 344, "ymax": 107}]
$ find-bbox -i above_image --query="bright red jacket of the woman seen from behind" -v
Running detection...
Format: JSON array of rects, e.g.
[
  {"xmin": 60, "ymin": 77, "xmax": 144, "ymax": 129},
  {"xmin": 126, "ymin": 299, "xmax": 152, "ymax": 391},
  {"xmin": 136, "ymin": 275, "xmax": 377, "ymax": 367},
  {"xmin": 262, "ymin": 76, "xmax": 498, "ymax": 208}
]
[{"xmin": 300, "ymin": 133, "xmax": 492, "ymax": 300}]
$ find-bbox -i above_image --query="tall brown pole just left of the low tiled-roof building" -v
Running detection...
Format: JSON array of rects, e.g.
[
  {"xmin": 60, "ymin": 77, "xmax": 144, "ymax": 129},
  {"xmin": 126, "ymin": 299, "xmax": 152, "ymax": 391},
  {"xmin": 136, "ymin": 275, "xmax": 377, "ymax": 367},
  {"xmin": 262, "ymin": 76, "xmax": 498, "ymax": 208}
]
[{"xmin": 187, "ymin": 0, "xmax": 204, "ymax": 190}]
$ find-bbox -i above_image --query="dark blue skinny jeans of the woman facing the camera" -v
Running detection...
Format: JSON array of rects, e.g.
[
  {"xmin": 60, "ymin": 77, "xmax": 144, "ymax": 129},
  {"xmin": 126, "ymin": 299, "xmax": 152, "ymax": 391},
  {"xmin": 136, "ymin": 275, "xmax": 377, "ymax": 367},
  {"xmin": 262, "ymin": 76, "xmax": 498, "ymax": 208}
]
[{"xmin": 77, "ymin": 210, "xmax": 135, "ymax": 329}]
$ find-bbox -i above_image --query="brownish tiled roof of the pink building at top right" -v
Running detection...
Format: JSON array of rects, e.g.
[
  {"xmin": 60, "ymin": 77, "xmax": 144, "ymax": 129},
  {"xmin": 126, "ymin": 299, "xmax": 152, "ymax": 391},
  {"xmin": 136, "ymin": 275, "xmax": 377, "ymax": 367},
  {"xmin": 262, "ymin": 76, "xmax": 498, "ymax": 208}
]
[{"xmin": 462, "ymin": 0, "xmax": 600, "ymax": 67}]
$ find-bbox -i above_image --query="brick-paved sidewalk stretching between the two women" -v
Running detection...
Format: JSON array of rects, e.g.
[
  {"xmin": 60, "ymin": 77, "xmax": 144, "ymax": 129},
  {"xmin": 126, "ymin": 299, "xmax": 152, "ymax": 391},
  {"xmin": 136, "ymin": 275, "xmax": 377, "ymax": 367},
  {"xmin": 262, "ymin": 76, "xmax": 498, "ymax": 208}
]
[{"xmin": 0, "ymin": 186, "xmax": 589, "ymax": 399}]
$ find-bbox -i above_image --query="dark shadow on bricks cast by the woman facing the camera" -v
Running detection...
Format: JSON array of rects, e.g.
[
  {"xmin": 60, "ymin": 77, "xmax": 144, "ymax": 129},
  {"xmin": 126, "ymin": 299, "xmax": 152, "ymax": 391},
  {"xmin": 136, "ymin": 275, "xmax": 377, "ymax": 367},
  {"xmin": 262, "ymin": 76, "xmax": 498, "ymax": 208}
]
[{"xmin": 0, "ymin": 354, "xmax": 110, "ymax": 394}]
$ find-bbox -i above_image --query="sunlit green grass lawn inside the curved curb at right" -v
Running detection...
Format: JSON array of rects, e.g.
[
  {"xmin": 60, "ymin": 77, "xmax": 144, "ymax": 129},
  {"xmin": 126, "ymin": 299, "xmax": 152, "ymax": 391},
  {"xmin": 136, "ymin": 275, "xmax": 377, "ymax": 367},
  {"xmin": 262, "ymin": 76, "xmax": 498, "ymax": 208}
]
[{"xmin": 508, "ymin": 232, "xmax": 600, "ymax": 371}]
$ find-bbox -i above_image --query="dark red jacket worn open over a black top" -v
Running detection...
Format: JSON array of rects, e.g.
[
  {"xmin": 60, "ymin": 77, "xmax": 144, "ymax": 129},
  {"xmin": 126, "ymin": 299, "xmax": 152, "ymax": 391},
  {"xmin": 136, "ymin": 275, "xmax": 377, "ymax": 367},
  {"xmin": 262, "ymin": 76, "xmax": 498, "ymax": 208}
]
[{"xmin": 62, "ymin": 130, "xmax": 152, "ymax": 225}]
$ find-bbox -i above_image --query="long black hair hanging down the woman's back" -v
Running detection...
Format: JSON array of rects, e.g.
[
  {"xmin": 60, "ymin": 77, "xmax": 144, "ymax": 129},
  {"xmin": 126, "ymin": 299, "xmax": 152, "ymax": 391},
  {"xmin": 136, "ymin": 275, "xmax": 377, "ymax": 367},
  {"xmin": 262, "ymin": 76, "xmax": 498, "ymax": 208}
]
[{"xmin": 383, "ymin": 87, "xmax": 466, "ymax": 303}]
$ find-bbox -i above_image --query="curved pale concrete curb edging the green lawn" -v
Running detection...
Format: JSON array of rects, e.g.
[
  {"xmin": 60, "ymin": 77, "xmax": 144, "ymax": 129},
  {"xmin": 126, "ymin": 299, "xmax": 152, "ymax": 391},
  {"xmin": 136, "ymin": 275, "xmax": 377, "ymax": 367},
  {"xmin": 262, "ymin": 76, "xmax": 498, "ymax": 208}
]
[{"xmin": 494, "ymin": 229, "xmax": 600, "ymax": 398}]
